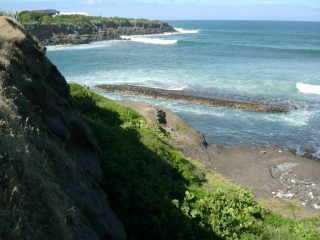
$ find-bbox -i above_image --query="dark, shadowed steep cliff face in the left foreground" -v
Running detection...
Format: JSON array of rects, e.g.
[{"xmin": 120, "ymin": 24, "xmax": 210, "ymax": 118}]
[{"xmin": 0, "ymin": 17, "xmax": 125, "ymax": 240}]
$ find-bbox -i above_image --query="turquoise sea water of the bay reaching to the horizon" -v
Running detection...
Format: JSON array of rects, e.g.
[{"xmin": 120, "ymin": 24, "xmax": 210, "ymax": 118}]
[{"xmin": 48, "ymin": 21, "xmax": 320, "ymax": 152}]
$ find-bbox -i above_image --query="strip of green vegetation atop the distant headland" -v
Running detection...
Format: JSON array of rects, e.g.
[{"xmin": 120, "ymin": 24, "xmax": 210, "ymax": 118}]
[{"xmin": 18, "ymin": 11, "xmax": 164, "ymax": 28}]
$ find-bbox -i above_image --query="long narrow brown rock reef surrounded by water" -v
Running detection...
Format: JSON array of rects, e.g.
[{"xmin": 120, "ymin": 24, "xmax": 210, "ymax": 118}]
[{"xmin": 96, "ymin": 84, "xmax": 290, "ymax": 113}]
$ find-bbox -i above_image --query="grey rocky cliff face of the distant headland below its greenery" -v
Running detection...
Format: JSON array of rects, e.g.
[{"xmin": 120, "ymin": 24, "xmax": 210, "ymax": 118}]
[{"xmin": 25, "ymin": 21, "xmax": 175, "ymax": 45}]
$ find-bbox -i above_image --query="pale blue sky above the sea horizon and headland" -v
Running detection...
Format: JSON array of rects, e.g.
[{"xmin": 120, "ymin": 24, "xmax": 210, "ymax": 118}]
[{"xmin": 0, "ymin": 0, "xmax": 320, "ymax": 21}]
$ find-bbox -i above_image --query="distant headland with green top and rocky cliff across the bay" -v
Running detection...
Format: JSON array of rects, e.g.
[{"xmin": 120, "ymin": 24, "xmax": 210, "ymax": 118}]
[{"xmin": 19, "ymin": 12, "xmax": 175, "ymax": 45}]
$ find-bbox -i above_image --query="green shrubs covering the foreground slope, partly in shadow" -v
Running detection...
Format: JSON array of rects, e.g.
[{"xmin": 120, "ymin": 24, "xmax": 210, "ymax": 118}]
[{"xmin": 71, "ymin": 84, "xmax": 320, "ymax": 240}]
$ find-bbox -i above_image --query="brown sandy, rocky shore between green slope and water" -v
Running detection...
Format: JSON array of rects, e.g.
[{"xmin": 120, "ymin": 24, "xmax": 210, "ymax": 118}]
[{"xmin": 121, "ymin": 101, "xmax": 320, "ymax": 217}]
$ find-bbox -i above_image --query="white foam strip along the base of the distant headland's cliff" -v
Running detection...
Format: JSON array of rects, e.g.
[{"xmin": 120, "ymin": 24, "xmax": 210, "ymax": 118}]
[{"xmin": 47, "ymin": 40, "xmax": 120, "ymax": 51}]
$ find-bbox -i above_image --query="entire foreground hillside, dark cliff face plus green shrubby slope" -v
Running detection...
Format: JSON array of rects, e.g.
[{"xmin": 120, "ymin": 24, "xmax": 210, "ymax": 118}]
[{"xmin": 0, "ymin": 18, "xmax": 320, "ymax": 240}]
